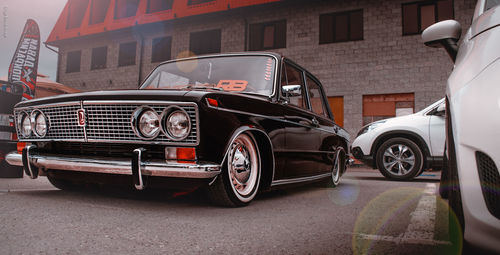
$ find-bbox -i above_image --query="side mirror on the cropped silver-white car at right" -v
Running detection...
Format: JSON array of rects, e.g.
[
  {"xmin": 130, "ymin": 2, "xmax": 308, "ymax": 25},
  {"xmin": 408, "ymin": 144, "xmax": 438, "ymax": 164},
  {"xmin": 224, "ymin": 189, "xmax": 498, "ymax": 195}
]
[{"xmin": 422, "ymin": 20, "xmax": 462, "ymax": 62}]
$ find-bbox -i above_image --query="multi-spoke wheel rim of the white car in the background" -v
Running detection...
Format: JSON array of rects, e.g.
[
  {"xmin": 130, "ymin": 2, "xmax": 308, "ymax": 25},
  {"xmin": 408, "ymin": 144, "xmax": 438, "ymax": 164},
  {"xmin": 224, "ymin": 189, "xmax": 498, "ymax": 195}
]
[{"xmin": 383, "ymin": 144, "xmax": 416, "ymax": 175}]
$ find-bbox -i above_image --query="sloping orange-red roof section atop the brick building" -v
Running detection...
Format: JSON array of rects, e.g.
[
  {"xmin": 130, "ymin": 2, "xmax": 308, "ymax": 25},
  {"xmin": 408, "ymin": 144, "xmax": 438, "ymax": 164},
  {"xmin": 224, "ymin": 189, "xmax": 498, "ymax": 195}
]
[{"xmin": 47, "ymin": 0, "xmax": 283, "ymax": 45}]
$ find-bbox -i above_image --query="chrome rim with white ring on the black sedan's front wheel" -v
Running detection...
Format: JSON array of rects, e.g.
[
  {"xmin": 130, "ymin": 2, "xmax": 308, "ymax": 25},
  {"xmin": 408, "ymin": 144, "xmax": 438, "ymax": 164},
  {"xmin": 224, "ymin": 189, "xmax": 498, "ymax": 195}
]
[{"xmin": 228, "ymin": 134, "xmax": 259, "ymax": 201}]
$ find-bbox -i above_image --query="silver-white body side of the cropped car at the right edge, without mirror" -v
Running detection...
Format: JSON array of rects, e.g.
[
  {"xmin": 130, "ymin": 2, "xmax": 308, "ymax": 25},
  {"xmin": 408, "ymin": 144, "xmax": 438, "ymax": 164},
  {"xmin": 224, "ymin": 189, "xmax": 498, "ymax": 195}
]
[{"xmin": 440, "ymin": 0, "xmax": 500, "ymax": 252}]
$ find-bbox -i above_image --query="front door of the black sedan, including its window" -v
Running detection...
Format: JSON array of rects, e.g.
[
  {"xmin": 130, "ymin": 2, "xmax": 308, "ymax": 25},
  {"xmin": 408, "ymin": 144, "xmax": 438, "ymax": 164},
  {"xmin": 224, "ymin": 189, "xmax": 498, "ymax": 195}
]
[{"xmin": 282, "ymin": 61, "xmax": 320, "ymax": 179}]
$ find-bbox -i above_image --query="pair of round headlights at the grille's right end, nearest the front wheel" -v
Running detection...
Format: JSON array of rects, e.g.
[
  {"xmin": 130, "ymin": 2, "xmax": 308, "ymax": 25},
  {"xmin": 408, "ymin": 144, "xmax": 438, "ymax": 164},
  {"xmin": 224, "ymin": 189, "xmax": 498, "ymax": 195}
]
[{"xmin": 131, "ymin": 106, "xmax": 191, "ymax": 141}]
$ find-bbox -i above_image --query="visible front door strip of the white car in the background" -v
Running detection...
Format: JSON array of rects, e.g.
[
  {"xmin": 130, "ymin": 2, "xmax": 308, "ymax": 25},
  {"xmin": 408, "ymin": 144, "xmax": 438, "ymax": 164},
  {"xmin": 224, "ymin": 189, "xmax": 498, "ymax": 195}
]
[{"xmin": 429, "ymin": 101, "xmax": 446, "ymax": 157}]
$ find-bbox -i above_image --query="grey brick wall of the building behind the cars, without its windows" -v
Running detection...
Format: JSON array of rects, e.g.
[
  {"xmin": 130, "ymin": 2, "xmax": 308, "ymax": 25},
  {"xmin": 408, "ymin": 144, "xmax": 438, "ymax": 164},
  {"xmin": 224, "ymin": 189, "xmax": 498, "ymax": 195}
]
[{"xmin": 59, "ymin": 0, "xmax": 475, "ymax": 135}]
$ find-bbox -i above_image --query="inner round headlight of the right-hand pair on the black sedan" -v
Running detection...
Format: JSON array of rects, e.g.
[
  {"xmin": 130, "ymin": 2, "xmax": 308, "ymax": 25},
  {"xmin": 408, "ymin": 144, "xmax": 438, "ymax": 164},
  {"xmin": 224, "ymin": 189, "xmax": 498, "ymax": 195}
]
[{"xmin": 132, "ymin": 107, "xmax": 160, "ymax": 139}]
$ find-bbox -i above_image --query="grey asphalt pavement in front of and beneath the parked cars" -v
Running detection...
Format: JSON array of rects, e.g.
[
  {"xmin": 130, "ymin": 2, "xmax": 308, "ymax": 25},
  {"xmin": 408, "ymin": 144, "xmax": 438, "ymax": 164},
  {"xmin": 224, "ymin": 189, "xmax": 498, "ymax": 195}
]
[{"xmin": 0, "ymin": 167, "xmax": 461, "ymax": 254}]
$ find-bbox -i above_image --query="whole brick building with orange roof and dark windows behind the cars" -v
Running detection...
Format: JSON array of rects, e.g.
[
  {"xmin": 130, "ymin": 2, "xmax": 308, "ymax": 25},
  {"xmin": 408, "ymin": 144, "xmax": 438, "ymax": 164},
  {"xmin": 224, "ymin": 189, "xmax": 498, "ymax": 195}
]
[{"xmin": 47, "ymin": 0, "xmax": 475, "ymax": 135}]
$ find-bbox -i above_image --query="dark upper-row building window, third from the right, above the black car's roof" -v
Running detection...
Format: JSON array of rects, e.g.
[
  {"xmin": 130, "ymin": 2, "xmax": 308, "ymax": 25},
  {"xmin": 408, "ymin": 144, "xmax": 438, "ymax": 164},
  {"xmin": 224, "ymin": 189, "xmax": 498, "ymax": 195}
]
[{"xmin": 249, "ymin": 20, "xmax": 286, "ymax": 50}]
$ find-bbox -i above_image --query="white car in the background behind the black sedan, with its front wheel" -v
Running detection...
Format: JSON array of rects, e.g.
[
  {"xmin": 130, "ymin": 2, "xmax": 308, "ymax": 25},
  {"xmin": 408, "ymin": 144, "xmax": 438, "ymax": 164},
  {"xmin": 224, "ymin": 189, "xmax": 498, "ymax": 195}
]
[{"xmin": 351, "ymin": 99, "xmax": 445, "ymax": 180}]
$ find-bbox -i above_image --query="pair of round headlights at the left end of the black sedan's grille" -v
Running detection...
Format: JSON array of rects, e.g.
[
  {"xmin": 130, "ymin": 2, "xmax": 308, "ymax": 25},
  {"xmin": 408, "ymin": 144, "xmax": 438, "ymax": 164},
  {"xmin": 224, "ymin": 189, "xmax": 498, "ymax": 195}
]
[{"xmin": 17, "ymin": 109, "xmax": 49, "ymax": 138}]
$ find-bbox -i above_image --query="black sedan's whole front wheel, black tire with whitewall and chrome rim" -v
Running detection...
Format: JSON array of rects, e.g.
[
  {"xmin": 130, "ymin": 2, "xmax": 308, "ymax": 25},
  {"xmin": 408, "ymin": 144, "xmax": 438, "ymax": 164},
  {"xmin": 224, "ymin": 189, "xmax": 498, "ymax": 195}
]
[{"xmin": 207, "ymin": 133, "xmax": 261, "ymax": 207}]
